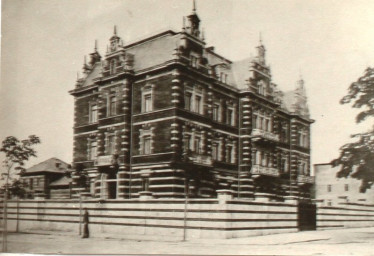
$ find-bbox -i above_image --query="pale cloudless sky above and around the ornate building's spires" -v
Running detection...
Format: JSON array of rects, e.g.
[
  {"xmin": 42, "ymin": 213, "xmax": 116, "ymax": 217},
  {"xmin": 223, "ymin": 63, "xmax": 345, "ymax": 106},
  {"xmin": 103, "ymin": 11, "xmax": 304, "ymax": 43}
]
[{"xmin": 0, "ymin": 0, "xmax": 374, "ymax": 171}]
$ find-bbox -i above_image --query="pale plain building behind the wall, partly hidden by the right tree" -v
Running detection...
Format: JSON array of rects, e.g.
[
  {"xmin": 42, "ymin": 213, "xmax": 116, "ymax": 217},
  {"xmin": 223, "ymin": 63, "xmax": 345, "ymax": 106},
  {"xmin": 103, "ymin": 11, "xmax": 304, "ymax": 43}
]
[{"xmin": 314, "ymin": 163, "xmax": 374, "ymax": 206}]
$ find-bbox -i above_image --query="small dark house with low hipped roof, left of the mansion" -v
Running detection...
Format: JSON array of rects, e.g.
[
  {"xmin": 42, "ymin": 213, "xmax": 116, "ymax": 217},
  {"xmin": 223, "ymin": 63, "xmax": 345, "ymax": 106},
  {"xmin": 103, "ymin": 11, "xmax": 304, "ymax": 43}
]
[{"xmin": 20, "ymin": 158, "xmax": 71, "ymax": 199}]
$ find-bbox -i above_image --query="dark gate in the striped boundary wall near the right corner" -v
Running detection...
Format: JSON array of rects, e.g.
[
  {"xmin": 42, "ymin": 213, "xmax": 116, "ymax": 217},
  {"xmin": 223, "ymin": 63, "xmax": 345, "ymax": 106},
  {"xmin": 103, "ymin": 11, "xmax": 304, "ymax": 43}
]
[{"xmin": 297, "ymin": 202, "xmax": 317, "ymax": 231}]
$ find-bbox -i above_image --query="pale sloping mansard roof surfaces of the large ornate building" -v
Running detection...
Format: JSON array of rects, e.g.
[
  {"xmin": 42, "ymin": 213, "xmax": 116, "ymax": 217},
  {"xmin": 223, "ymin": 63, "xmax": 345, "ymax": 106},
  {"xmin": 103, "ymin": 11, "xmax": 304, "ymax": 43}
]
[{"xmin": 73, "ymin": 30, "xmax": 309, "ymax": 118}]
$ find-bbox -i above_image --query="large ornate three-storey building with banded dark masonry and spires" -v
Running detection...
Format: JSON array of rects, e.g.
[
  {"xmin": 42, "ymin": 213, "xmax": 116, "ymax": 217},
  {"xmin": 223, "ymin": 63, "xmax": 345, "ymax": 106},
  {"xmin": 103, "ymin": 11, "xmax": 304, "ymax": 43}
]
[{"xmin": 70, "ymin": 4, "xmax": 313, "ymax": 200}]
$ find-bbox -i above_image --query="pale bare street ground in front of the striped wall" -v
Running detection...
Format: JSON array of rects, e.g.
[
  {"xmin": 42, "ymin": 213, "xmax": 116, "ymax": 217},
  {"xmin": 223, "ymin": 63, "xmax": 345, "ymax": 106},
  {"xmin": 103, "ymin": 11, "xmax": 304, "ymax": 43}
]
[{"xmin": 3, "ymin": 227, "xmax": 374, "ymax": 255}]
